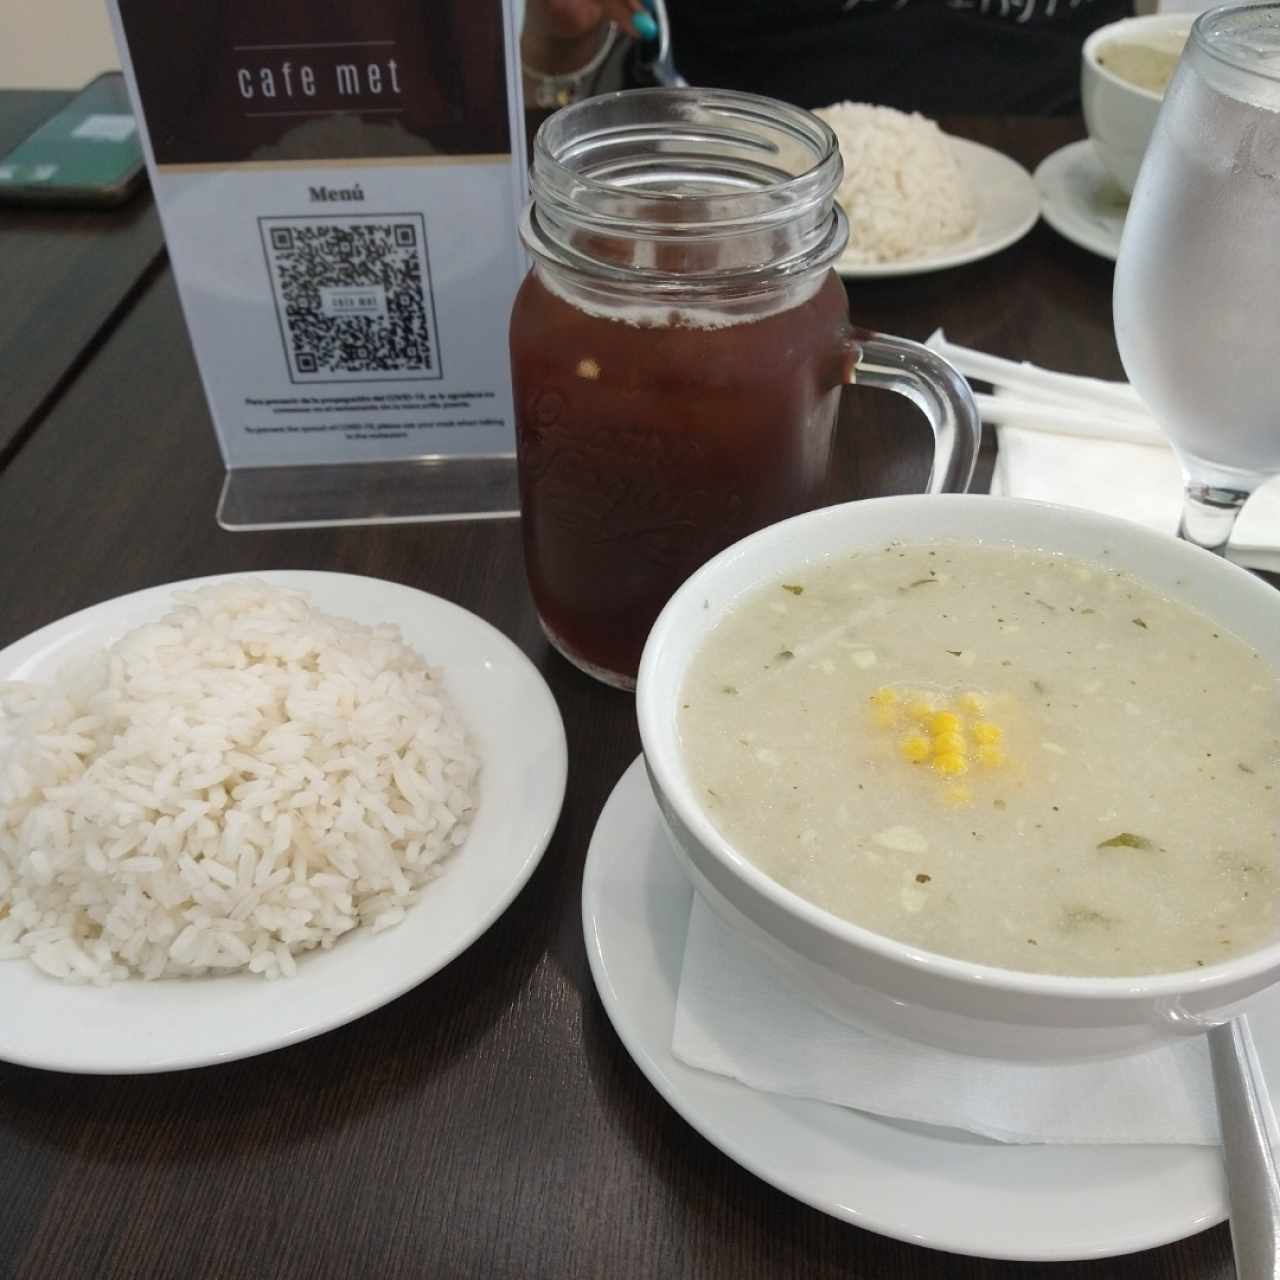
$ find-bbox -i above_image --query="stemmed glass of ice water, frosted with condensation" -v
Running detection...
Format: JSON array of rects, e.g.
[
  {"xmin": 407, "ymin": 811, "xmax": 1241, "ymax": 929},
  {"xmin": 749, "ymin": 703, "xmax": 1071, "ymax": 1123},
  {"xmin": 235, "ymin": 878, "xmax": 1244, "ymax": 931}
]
[{"xmin": 1114, "ymin": 4, "xmax": 1280, "ymax": 553}]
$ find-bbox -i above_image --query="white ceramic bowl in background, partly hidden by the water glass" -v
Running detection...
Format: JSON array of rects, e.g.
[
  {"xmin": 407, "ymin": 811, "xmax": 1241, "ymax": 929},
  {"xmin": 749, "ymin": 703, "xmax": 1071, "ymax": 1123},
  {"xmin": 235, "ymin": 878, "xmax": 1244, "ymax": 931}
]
[{"xmin": 1080, "ymin": 13, "xmax": 1196, "ymax": 195}]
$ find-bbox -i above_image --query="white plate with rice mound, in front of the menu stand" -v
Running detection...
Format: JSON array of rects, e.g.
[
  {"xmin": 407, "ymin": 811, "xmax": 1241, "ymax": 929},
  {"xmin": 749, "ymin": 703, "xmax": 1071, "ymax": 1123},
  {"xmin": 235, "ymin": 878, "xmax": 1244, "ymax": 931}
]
[{"xmin": 0, "ymin": 571, "xmax": 567, "ymax": 1073}]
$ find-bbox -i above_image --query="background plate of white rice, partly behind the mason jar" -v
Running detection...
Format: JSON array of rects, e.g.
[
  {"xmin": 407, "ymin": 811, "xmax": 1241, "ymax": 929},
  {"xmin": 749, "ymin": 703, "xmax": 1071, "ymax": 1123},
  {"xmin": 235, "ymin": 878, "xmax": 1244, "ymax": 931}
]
[{"xmin": 814, "ymin": 102, "xmax": 1039, "ymax": 280}]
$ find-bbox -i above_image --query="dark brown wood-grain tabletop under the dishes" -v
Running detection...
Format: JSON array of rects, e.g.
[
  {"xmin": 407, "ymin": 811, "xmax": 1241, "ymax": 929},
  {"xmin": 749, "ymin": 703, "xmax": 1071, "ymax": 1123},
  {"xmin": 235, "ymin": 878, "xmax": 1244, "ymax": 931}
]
[{"xmin": 0, "ymin": 112, "xmax": 1231, "ymax": 1280}]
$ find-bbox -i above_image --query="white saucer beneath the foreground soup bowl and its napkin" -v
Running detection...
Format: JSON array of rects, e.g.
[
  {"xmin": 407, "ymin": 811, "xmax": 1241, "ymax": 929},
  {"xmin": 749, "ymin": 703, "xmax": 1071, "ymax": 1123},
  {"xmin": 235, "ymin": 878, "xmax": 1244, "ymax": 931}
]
[{"xmin": 582, "ymin": 760, "xmax": 1259, "ymax": 1261}]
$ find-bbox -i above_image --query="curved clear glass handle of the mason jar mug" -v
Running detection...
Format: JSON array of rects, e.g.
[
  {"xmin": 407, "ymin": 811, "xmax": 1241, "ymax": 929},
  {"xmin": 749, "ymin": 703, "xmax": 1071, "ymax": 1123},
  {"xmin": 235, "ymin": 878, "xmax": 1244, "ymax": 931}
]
[{"xmin": 846, "ymin": 330, "xmax": 982, "ymax": 493}]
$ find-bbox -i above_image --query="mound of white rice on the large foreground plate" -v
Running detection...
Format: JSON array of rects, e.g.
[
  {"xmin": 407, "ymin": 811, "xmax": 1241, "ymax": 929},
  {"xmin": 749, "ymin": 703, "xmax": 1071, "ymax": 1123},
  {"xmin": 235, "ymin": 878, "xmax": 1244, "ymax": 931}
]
[{"xmin": 0, "ymin": 580, "xmax": 479, "ymax": 984}]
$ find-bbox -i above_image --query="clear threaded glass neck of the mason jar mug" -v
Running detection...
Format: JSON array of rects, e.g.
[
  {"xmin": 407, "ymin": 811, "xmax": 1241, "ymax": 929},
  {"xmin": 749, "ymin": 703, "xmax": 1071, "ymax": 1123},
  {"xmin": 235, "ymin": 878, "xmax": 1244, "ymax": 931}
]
[{"xmin": 521, "ymin": 87, "xmax": 847, "ymax": 292}]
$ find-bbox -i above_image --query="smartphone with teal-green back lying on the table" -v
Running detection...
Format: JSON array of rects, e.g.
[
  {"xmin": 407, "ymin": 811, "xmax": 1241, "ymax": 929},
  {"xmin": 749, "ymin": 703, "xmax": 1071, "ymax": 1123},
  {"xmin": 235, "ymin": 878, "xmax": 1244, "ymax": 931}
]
[{"xmin": 0, "ymin": 72, "xmax": 146, "ymax": 209}]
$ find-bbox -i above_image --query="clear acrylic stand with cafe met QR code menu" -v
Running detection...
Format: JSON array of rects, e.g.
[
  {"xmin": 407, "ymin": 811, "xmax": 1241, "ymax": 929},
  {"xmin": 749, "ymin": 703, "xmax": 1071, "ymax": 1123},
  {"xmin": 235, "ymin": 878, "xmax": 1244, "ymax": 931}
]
[{"xmin": 113, "ymin": 0, "xmax": 527, "ymax": 530}]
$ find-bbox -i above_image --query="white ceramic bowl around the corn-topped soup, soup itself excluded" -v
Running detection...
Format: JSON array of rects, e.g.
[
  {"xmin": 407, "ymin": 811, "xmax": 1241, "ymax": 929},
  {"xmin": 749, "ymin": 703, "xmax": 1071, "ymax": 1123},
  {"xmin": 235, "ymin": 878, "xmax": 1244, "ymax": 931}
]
[{"xmin": 636, "ymin": 495, "xmax": 1280, "ymax": 1061}]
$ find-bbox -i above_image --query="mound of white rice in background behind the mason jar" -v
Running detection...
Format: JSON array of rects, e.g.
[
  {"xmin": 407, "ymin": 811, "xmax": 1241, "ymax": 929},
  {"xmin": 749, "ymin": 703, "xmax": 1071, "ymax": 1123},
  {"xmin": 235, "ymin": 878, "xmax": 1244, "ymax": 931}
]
[{"xmin": 814, "ymin": 102, "xmax": 978, "ymax": 265}]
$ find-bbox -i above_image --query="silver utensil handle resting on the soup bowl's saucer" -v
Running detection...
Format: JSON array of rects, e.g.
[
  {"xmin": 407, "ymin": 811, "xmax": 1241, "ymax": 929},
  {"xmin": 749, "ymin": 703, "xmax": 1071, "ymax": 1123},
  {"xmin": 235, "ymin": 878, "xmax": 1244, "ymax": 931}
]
[{"xmin": 1208, "ymin": 1018, "xmax": 1280, "ymax": 1280}]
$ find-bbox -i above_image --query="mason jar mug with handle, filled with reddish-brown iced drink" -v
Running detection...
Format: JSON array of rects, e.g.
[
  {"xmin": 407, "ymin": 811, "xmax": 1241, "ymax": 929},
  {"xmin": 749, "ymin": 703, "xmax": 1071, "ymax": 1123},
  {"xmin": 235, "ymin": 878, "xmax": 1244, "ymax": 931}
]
[{"xmin": 511, "ymin": 88, "xmax": 980, "ymax": 689}]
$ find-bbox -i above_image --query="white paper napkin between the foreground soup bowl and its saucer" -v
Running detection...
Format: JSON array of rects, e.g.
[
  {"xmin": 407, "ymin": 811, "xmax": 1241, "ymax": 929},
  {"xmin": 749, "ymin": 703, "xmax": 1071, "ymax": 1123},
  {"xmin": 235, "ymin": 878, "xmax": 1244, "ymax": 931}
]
[{"xmin": 671, "ymin": 893, "xmax": 1219, "ymax": 1146}]
